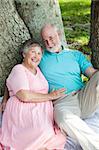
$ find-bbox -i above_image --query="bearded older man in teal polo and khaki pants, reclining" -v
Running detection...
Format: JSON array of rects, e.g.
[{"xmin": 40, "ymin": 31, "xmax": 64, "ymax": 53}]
[{"xmin": 40, "ymin": 24, "xmax": 99, "ymax": 150}]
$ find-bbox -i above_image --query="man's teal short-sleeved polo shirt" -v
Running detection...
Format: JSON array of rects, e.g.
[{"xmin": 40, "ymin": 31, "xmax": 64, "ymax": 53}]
[{"xmin": 39, "ymin": 50, "xmax": 92, "ymax": 94}]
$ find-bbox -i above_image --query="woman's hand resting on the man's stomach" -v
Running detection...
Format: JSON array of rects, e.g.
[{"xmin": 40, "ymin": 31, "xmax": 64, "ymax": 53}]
[{"xmin": 49, "ymin": 88, "xmax": 66, "ymax": 100}]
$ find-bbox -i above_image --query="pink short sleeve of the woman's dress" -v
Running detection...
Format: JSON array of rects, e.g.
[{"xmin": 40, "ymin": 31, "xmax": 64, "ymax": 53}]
[{"xmin": 6, "ymin": 64, "xmax": 29, "ymax": 94}]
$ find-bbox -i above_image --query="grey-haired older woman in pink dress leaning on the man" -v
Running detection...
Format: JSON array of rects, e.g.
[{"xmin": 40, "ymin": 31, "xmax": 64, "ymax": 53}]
[{"xmin": 0, "ymin": 40, "xmax": 66, "ymax": 150}]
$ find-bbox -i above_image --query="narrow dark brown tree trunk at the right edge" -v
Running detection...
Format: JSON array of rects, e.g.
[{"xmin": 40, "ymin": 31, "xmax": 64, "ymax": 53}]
[{"xmin": 91, "ymin": 0, "xmax": 99, "ymax": 69}]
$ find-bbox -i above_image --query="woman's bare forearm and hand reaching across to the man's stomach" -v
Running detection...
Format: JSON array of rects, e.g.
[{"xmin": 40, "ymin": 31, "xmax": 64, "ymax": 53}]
[{"xmin": 16, "ymin": 88, "xmax": 65, "ymax": 103}]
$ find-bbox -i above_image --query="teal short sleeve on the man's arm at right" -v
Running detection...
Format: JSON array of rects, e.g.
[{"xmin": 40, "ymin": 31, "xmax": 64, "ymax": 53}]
[{"xmin": 74, "ymin": 51, "xmax": 92, "ymax": 74}]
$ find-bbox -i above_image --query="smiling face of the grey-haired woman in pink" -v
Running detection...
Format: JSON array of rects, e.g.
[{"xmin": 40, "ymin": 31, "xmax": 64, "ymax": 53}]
[{"xmin": 23, "ymin": 46, "xmax": 42, "ymax": 68}]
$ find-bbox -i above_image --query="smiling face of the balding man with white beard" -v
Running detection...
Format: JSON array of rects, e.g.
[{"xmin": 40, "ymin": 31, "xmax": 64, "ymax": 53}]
[{"xmin": 42, "ymin": 27, "xmax": 61, "ymax": 52}]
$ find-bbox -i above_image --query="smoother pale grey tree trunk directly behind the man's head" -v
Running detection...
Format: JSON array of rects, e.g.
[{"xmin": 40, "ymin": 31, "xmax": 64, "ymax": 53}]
[{"xmin": 15, "ymin": 0, "xmax": 65, "ymax": 42}]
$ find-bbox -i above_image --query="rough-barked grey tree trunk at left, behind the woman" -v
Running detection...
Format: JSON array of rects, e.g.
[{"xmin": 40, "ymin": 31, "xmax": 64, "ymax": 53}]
[{"xmin": 0, "ymin": 0, "xmax": 30, "ymax": 95}]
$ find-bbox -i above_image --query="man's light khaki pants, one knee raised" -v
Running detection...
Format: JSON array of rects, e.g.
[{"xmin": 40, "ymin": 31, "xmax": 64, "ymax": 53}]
[{"xmin": 54, "ymin": 72, "xmax": 99, "ymax": 150}]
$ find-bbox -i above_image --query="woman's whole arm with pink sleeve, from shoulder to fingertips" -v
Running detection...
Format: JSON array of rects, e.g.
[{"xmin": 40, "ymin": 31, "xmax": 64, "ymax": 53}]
[{"xmin": 7, "ymin": 65, "xmax": 65, "ymax": 103}]
